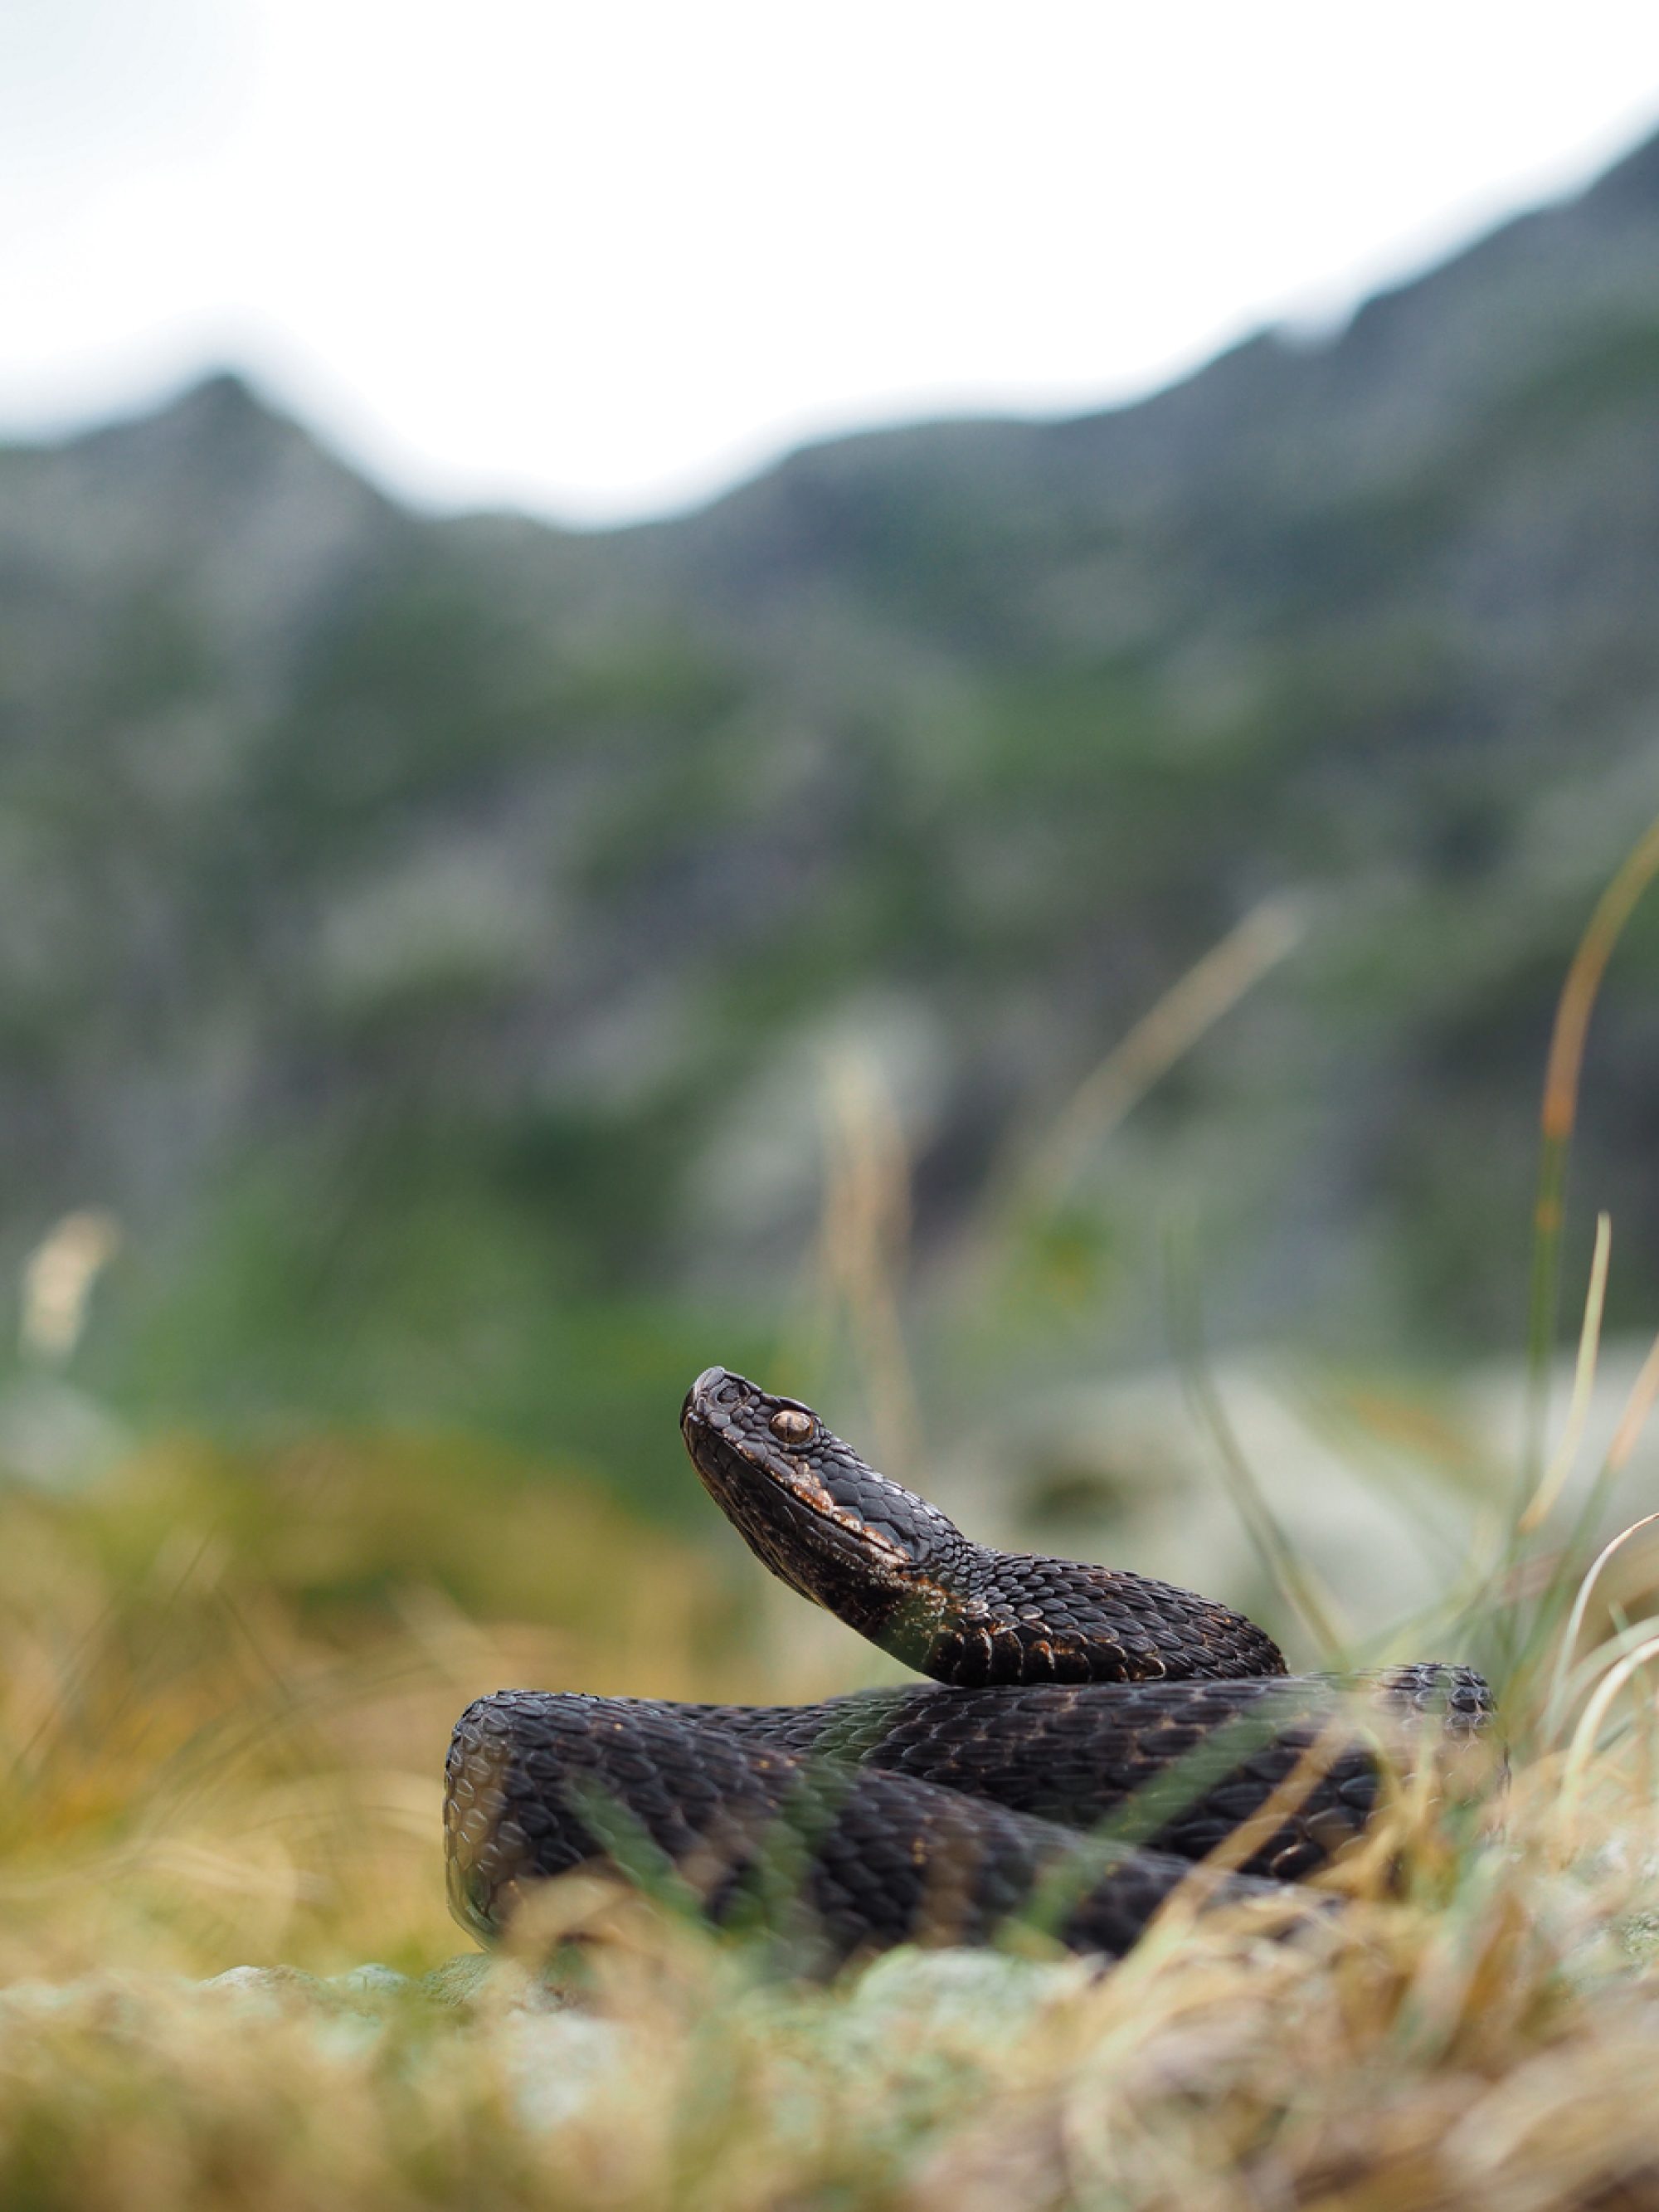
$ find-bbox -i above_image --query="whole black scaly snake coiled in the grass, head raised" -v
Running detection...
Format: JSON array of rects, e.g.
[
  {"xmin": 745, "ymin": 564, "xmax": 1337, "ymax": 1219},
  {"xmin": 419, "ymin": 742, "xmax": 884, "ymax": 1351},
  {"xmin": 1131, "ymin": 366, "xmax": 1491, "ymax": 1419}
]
[{"xmin": 445, "ymin": 1367, "xmax": 1493, "ymax": 1960}]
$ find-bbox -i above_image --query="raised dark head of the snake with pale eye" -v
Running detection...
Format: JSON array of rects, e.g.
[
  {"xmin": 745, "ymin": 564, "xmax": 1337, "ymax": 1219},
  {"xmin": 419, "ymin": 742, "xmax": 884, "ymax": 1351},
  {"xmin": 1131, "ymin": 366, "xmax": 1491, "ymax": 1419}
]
[{"xmin": 679, "ymin": 1367, "xmax": 978, "ymax": 1650}]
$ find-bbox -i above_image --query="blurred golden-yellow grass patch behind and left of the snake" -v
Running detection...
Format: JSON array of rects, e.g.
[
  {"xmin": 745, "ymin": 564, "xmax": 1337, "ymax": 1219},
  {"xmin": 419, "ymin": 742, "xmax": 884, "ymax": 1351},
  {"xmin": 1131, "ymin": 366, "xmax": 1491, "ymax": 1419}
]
[{"xmin": 0, "ymin": 1440, "xmax": 752, "ymax": 1980}]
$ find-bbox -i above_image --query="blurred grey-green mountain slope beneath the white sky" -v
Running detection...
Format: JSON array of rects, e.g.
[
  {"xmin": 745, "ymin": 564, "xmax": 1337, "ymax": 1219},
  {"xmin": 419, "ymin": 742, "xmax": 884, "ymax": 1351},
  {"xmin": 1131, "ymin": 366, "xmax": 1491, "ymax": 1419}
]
[{"xmin": 0, "ymin": 142, "xmax": 1659, "ymax": 1450}]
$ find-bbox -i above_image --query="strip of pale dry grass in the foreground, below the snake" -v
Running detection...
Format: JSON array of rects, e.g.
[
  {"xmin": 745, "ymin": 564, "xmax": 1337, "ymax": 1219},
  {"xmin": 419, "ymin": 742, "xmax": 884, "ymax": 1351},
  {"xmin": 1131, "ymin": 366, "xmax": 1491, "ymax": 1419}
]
[{"xmin": 0, "ymin": 1765, "xmax": 1659, "ymax": 2212}]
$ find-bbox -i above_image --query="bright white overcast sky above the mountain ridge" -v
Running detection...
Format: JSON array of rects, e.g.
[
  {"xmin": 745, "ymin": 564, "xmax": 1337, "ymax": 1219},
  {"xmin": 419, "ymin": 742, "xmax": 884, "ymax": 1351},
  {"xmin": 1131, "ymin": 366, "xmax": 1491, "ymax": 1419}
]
[{"xmin": 0, "ymin": 0, "xmax": 1659, "ymax": 522}]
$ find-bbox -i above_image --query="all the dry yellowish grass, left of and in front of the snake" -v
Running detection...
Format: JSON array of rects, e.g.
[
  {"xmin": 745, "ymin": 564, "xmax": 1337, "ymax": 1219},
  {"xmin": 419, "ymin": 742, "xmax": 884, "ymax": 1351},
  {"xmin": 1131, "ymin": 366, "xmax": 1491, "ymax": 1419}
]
[{"xmin": 0, "ymin": 1406, "xmax": 1659, "ymax": 2212}]
